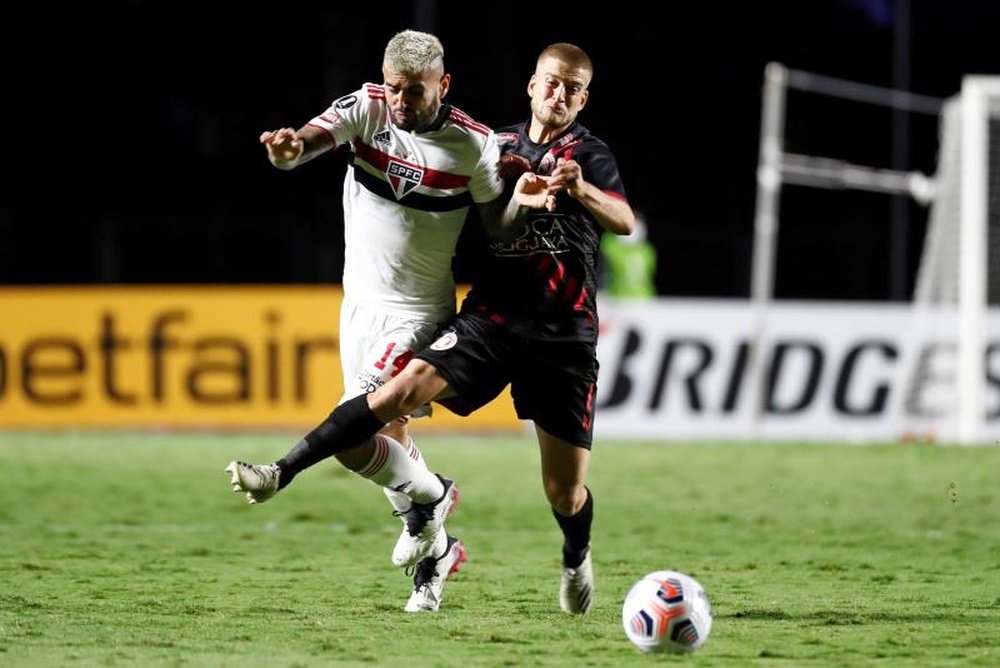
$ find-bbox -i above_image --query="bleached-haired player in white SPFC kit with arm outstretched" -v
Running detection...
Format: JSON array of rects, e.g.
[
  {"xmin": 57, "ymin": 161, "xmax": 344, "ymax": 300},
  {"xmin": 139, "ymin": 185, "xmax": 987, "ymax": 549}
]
[{"xmin": 226, "ymin": 30, "xmax": 552, "ymax": 612}]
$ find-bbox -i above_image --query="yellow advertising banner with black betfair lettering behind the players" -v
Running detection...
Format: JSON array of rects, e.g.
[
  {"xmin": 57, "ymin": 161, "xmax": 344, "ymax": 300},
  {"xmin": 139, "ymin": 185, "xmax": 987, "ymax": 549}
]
[{"xmin": 0, "ymin": 286, "xmax": 520, "ymax": 431}]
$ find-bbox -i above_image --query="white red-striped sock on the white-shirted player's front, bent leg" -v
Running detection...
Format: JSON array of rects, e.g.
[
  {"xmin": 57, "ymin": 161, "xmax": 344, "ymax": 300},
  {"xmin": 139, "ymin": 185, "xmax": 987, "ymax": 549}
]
[{"xmin": 358, "ymin": 434, "xmax": 444, "ymax": 504}]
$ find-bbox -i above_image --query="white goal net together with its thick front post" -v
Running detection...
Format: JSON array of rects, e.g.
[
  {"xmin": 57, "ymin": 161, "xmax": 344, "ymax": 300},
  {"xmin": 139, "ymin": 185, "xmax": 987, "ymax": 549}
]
[{"xmin": 897, "ymin": 76, "xmax": 1000, "ymax": 444}]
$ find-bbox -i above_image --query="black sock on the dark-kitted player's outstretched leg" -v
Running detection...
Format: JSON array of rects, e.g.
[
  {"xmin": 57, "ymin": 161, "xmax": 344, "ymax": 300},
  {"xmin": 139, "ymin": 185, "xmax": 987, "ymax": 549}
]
[{"xmin": 275, "ymin": 394, "xmax": 385, "ymax": 489}]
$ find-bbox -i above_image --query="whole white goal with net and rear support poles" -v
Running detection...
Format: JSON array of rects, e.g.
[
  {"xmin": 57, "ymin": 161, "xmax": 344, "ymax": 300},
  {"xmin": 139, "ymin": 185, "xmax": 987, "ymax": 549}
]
[{"xmin": 748, "ymin": 63, "xmax": 1000, "ymax": 444}]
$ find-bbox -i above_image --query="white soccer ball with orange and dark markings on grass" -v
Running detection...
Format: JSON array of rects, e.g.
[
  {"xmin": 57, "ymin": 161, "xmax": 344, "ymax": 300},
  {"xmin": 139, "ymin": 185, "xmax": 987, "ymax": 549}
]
[{"xmin": 622, "ymin": 571, "xmax": 712, "ymax": 652}]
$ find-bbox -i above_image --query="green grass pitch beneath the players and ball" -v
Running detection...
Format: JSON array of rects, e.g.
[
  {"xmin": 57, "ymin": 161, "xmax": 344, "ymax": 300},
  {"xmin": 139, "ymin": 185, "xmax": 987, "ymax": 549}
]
[{"xmin": 0, "ymin": 432, "xmax": 1000, "ymax": 668}]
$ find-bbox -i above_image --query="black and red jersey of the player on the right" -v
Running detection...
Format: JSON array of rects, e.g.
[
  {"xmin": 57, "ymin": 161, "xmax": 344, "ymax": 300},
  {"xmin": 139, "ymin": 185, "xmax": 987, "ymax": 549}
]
[{"xmin": 462, "ymin": 123, "xmax": 626, "ymax": 341}]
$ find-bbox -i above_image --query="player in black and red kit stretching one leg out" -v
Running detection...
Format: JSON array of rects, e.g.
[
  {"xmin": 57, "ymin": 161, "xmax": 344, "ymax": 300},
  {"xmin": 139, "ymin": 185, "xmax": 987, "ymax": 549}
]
[{"xmin": 229, "ymin": 43, "xmax": 635, "ymax": 614}]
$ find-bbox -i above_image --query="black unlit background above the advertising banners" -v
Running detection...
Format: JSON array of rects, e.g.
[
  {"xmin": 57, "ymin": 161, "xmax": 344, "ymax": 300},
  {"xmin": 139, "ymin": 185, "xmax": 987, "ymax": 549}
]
[{"xmin": 0, "ymin": 0, "xmax": 1000, "ymax": 300}]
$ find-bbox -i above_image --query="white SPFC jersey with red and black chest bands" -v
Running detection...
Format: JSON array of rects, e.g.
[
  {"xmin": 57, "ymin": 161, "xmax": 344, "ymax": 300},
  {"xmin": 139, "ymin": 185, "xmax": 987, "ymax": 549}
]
[{"xmin": 309, "ymin": 83, "xmax": 503, "ymax": 321}]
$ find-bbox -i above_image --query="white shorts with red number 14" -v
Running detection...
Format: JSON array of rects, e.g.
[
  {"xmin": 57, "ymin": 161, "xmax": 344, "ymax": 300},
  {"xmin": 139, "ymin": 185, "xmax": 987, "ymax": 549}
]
[{"xmin": 340, "ymin": 298, "xmax": 448, "ymax": 403}]
